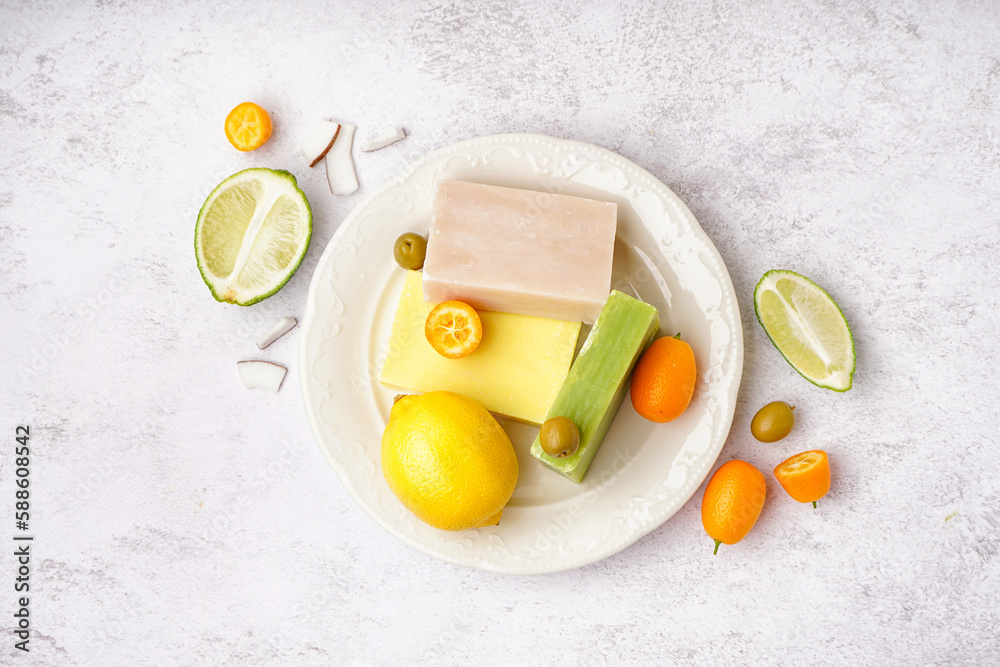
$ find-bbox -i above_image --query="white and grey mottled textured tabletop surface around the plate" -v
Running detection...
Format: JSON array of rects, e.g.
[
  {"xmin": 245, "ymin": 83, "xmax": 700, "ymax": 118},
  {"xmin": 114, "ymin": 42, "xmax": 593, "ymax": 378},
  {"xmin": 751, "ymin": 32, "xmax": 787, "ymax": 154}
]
[{"xmin": 0, "ymin": 0, "xmax": 1000, "ymax": 665}]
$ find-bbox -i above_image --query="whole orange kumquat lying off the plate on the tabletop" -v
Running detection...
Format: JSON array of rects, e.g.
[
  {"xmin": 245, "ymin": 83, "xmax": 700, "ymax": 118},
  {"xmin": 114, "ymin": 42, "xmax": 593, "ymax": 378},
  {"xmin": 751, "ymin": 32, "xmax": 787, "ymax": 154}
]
[{"xmin": 701, "ymin": 460, "xmax": 767, "ymax": 554}]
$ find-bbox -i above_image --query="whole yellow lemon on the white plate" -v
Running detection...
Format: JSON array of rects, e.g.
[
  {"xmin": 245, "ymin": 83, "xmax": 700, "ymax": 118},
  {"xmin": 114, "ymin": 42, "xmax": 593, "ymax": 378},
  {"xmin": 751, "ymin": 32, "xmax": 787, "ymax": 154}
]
[{"xmin": 382, "ymin": 391, "xmax": 517, "ymax": 530}]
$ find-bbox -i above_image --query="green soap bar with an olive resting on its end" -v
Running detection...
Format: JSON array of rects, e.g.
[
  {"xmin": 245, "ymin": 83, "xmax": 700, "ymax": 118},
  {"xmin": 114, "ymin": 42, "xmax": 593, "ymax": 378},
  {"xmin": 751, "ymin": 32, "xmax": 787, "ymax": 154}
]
[{"xmin": 531, "ymin": 291, "xmax": 660, "ymax": 484}]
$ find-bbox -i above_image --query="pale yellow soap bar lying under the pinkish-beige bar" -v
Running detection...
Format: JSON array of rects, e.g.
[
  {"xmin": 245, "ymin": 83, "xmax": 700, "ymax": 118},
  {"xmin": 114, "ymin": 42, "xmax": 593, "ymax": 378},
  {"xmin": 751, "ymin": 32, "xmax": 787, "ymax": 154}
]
[{"xmin": 379, "ymin": 271, "xmax": 580, "ymax": 424}]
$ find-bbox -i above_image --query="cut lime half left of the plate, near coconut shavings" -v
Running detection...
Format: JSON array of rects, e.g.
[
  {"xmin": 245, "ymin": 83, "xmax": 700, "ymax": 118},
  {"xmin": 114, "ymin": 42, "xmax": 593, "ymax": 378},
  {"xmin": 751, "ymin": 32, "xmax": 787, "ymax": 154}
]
[{"xmin": 194, "ymin": 169, "xmax": 312, "ymax": 306}]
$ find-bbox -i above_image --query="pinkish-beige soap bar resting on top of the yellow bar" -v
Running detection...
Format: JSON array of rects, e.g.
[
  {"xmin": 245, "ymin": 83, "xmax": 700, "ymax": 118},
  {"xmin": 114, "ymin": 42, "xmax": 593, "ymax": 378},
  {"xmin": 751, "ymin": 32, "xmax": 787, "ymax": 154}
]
[{"xmin": 424, "ymin": 181, "xmax": 618, "ymax": 324}]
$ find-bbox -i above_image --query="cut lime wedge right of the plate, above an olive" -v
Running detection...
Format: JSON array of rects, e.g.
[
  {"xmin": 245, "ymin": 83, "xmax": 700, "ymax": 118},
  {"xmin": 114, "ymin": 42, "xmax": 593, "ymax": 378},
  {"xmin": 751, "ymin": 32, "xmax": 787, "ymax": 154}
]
[{"xmin": 753, "ymin": 269, "xmax": 854, "ymax": 391}]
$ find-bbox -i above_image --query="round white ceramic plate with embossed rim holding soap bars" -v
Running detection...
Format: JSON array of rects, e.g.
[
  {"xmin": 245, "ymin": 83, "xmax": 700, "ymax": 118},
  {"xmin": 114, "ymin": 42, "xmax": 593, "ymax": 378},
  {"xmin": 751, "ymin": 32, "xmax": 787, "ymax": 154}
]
[{"xmin": 299, "ymin": 134, "xmax": 743, "ymax": 574}]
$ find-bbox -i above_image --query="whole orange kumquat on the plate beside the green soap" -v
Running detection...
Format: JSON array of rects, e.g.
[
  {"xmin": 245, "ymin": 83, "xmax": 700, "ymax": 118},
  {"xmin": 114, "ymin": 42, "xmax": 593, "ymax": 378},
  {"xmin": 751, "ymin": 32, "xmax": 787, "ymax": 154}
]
[{"xmin": 629, "ymin": 337, "xmax": 698, "ymax": 424}]
